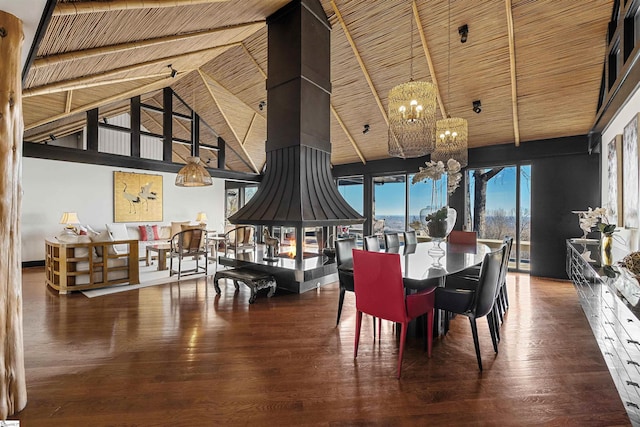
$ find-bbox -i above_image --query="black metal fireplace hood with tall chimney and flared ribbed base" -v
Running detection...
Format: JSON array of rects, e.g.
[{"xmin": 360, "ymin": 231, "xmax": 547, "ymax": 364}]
[{"xmin": 229, "ymin": 0, "xmax": 365, "ymax": 227}]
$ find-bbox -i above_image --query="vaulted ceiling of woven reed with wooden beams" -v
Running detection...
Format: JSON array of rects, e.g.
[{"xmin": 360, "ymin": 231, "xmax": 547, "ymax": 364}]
[{"xmin": 23, "ymin": 0, "xmax": 613, "ymax": 172}]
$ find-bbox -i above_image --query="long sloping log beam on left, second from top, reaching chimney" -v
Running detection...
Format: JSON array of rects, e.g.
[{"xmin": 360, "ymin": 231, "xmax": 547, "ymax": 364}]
[{"xmin": 31, "ymin": 20, "xmax": 265, "ymax": 69}]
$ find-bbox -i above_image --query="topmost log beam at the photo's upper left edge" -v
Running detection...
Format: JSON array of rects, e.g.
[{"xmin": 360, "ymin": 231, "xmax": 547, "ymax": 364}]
[{"xmin": 53, "ymin": 0, "xmax": 228, "ymax": 16}]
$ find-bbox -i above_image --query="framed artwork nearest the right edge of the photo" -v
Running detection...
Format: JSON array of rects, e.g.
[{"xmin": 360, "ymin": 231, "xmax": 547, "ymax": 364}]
[{"xmin": 620, "ymin": 114, "xmax": 639, "ymax": 228}]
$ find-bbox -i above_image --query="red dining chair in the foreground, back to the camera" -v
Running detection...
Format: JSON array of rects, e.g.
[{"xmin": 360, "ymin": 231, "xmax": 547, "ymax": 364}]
[{"xmin": 353, "ymin": 249, "xmax": 435, "ymax": 378}]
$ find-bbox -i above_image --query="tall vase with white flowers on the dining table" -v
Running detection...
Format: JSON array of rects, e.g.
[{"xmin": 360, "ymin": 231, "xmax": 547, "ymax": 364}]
[{"xmin": 412, "ymin": 159, "xmax": 462, "ymax": 258}]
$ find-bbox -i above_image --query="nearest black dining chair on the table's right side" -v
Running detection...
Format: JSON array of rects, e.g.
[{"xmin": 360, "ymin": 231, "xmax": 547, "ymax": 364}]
[{"xmin": 435, "ymin": 244, "xmax": 507, "ymax": 371}]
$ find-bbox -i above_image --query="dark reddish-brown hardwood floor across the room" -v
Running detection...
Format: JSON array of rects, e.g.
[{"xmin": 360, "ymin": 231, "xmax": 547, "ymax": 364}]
[{"xmin": 9, "ymin": 268, "xmax": 629, "ymax": 427}]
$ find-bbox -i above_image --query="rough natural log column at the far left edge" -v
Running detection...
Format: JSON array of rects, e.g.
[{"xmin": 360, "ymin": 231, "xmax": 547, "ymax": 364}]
[{"xmin": 0, "ymin": 11, "xmax": 27, "ymax": 420}]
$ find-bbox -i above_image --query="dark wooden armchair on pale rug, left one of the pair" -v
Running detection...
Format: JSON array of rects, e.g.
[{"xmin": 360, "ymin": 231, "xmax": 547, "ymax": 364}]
[{"xmin": 169, "ymin": 228, "xmax": 209, "ymax": 279}]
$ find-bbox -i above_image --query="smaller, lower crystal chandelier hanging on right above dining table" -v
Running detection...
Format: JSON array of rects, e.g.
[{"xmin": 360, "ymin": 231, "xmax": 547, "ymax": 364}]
[{"xmin": 431, "ymin": 0, "xmax": 469, "ymax": 167}]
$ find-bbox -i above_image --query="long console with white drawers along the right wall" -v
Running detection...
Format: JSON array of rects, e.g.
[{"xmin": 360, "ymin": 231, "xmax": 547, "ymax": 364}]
[{"xmin": 566, "ymin": 239, "xmax": 640, "ymax": 425}]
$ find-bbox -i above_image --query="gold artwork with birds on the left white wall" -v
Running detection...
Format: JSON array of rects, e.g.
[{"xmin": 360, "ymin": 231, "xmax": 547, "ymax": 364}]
[{"xmin": 113, "ymin": 172, "xmax": 162, "ymax": 222}]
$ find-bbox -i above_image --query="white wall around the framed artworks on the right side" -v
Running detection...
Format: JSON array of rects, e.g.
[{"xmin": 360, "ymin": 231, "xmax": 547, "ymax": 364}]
[{"xmin": 604, "ymin": 83, "xmax": 640, "ymax": 260}]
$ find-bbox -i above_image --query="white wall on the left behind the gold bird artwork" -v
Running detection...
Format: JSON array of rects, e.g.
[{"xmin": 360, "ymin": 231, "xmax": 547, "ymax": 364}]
[{"xmin": 21, "ymin": 157, "xmax": 225, "ymax": 262}]
